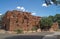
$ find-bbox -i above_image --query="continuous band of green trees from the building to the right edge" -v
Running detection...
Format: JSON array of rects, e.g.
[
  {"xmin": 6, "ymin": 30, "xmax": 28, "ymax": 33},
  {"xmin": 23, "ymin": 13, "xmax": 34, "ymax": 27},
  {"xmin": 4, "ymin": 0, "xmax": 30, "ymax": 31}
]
[{"xmin": 40, "ymin": 14, "xmax": 60, "ymax": 28}]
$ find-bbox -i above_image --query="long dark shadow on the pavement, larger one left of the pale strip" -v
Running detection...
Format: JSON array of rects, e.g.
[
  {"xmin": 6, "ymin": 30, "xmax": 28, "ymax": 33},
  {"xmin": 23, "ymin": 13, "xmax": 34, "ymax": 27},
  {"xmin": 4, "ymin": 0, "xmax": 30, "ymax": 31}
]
[{"xmin": 5, "ymin": 35, "xmax": 43, "ymax": 39}]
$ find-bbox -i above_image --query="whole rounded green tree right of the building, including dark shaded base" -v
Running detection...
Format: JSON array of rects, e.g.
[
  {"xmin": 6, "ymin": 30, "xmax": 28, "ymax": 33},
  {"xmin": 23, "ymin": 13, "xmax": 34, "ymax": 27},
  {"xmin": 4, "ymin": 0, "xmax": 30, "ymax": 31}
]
[{"xmin": 40, "ymin": 17, "xmax": 53, "ymax": 30}]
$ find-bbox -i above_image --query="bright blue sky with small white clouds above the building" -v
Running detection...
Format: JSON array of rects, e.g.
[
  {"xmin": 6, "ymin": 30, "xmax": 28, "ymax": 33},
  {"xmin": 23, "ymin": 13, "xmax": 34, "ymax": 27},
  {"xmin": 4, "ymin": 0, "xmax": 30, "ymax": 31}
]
[{"xmin": 0, "ymin": 0, "xmax": 60, "ymax": 16}]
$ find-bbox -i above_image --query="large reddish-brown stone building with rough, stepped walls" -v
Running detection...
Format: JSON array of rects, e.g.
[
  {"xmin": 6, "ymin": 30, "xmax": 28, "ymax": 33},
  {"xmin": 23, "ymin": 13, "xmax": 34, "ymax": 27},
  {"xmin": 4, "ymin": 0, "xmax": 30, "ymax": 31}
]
[{"xmin": 3, "ymin": 10, "xmax": 41, "ymax": 31}]
